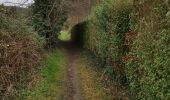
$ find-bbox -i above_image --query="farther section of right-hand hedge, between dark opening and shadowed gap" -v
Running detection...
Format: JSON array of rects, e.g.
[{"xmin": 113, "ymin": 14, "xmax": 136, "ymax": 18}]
[{"xmin": 85, "ymin": 0, "xmax": 131, "ymax": 83}]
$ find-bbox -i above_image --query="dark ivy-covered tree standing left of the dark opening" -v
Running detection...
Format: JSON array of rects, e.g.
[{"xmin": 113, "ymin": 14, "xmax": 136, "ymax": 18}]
[{"xmin": 33, "ymin": 0, "xmax": 67, "ymax": 46}]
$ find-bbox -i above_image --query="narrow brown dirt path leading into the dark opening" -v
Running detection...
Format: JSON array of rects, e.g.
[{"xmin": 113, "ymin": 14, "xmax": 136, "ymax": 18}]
[{"xmin": 64, "ymin": 43, "xmax": 82, "ymax": 100}]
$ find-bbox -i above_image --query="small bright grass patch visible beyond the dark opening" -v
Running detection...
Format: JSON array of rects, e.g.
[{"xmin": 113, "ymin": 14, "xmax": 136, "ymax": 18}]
[{"xmin": 59, "ymin": 31, "xmax": 71, "ymax": 41}]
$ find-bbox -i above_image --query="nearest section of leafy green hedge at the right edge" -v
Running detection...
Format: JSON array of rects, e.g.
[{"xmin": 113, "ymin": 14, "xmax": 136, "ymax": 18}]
[{"xmin": 126, "ymin": 0, "xmax": 170, "ymax": 100}]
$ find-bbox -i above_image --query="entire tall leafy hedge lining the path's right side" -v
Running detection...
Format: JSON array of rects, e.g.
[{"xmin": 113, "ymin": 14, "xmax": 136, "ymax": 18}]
[{"xmin": 71, "ymin": 0, "xmax": 170, "ymax": 100}]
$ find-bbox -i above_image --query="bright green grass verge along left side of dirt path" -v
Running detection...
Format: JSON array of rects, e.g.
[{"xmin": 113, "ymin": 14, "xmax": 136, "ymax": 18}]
[{"xmin": 27, "ymin": 50, "xmax": 67, "ymax": 100}]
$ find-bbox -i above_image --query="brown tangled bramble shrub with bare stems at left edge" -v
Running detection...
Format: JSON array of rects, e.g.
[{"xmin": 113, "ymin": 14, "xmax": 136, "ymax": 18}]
[{"xmin": 0, "ymin": 7, "xmax": 42, "ymax": 99}]
